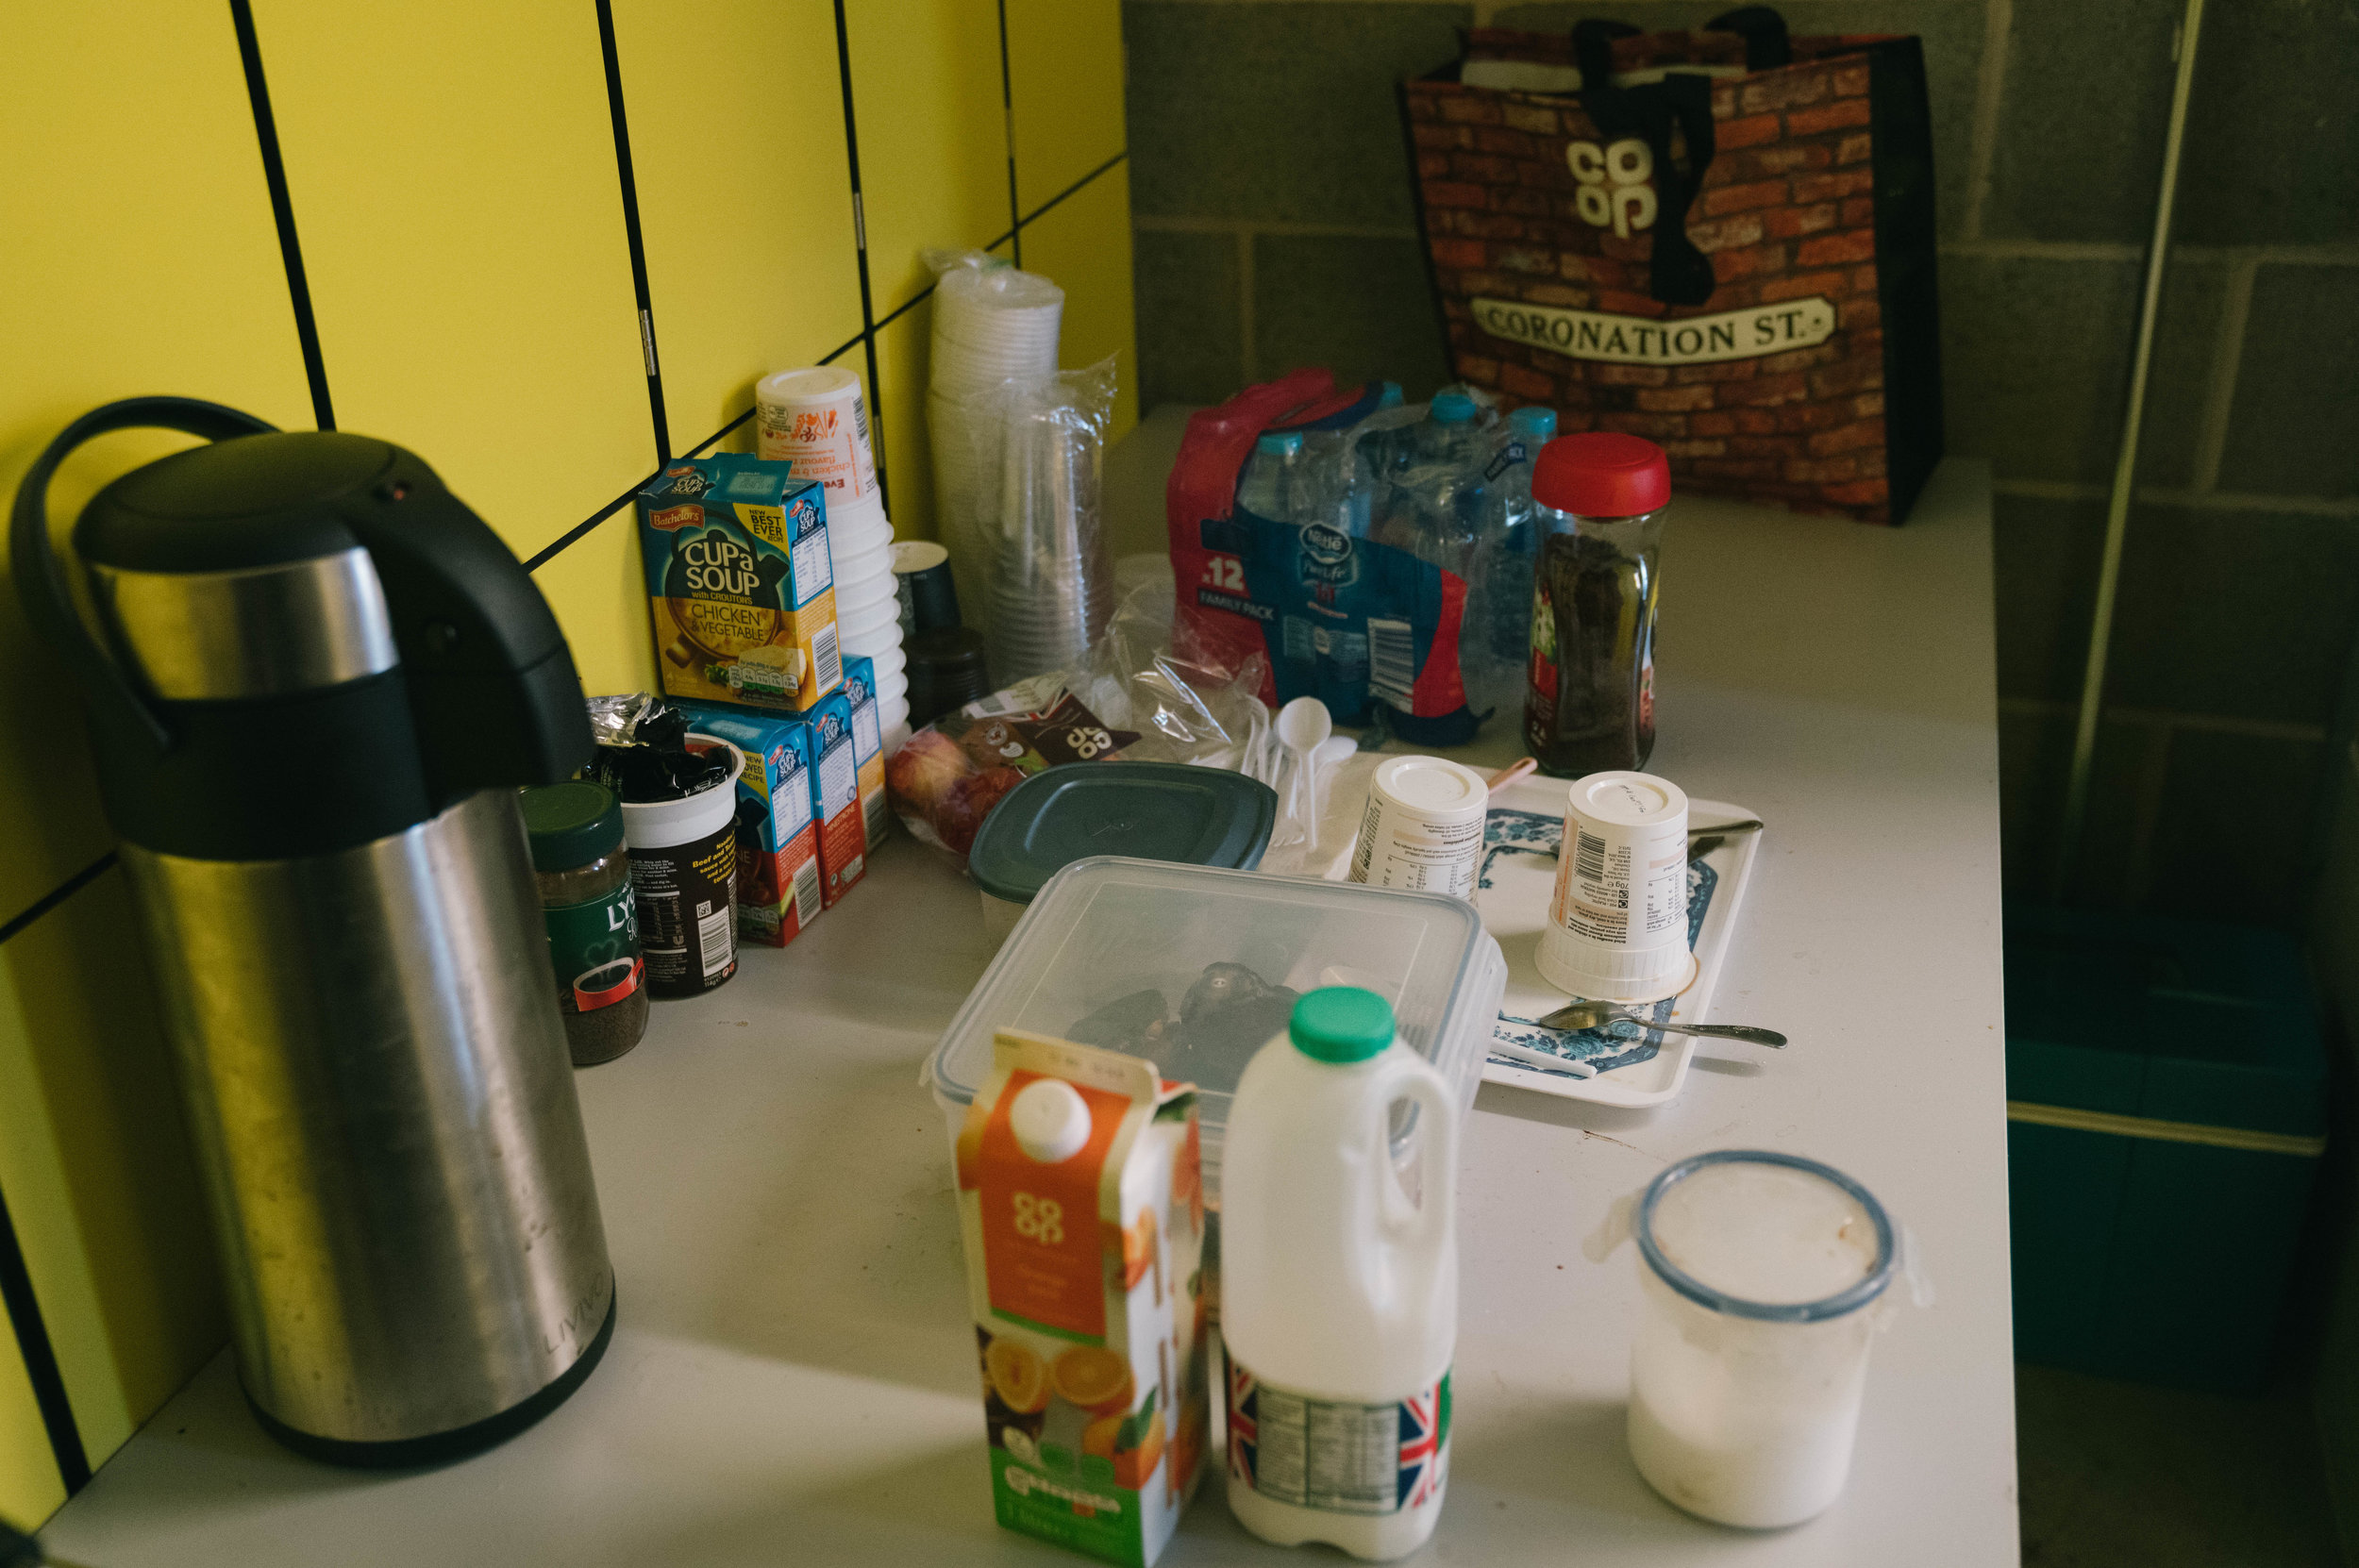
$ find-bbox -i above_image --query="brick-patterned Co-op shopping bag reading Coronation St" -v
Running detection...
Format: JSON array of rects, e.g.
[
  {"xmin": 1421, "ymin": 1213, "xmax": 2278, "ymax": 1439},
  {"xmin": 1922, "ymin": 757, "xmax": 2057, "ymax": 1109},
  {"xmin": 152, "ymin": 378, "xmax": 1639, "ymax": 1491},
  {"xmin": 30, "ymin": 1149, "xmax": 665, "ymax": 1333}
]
[{"xmin": 1401, "ymin": 7, "xmax": 1942, "ymax": 524}]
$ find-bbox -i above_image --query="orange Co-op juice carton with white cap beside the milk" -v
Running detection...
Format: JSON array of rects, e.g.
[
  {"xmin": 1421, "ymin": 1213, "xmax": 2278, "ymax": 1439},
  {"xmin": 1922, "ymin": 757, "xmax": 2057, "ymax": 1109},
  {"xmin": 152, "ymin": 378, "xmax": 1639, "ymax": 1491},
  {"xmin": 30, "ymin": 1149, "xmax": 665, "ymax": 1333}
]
[{"xmin": 958, "ymin": 1030, "xmax": 1211, "ymax": 1568}]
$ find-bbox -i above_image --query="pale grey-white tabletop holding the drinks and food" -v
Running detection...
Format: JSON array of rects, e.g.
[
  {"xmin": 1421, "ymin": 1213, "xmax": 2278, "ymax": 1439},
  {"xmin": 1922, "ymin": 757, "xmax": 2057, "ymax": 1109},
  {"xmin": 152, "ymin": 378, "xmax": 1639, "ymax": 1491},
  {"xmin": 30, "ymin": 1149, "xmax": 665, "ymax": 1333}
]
[{"xmin": 45, "ymin": 420, "xmax": 2017, "ymax": 1568}]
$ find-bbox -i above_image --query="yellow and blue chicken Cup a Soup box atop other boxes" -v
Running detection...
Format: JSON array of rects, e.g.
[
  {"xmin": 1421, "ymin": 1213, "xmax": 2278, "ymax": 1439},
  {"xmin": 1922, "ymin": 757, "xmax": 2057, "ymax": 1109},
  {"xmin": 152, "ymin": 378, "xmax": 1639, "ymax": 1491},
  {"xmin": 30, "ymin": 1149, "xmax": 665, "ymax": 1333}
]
[{"xmin": 637, "ymin": 453, "xmax": 845, "ymax": 712}]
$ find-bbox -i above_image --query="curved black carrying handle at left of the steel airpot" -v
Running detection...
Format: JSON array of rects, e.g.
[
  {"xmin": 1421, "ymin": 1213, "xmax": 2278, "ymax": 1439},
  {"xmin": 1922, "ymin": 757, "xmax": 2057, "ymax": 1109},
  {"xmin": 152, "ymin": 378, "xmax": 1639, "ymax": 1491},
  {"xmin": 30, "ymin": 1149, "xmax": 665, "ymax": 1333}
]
[{"xmin": 9, "ymin": 398, "xmax": 278, "ymax": 759}]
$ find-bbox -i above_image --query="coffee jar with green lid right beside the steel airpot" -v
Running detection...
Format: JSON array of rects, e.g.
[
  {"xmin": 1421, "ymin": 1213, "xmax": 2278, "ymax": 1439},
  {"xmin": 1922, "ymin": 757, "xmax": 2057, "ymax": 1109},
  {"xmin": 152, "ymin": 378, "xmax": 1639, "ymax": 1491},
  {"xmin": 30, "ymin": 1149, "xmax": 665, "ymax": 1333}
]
[{"xmin": 519, "ymin": 778, "xmax": 646, "ymax": 1068}]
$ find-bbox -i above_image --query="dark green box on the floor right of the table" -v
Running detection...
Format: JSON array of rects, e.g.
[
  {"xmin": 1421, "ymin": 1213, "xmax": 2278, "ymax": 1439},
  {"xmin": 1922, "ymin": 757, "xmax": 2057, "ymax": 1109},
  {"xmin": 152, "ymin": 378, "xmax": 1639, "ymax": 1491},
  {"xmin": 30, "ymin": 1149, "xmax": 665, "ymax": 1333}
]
[{"xmin": 2005, "ymin": 908, "xmax": 2326, "ymax": 1393}]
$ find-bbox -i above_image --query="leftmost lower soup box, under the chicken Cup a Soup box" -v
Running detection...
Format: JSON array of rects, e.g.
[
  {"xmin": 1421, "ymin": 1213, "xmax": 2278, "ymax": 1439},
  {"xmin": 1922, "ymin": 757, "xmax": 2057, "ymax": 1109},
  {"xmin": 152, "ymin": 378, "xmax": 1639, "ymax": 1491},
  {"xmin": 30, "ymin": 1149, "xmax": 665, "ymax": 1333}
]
[{"xmin": 679, "ymin": 703, "xmax": 826, "ymax": 948}]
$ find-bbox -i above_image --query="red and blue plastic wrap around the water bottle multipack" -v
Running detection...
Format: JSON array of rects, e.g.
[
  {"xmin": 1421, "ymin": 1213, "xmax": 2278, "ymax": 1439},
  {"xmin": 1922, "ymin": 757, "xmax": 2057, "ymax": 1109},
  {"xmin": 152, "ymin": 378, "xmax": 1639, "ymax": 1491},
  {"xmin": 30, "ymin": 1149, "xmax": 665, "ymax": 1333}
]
[{"xmin": 1165, "ymin": 370, "xmax": 1481, "ymax": 745}]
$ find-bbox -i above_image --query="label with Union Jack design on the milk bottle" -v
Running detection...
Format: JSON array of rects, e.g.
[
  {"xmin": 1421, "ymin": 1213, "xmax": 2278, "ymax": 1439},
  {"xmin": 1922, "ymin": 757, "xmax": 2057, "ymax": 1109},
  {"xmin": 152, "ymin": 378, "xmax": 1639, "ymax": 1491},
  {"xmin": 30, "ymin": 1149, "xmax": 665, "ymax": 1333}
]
[{"xmin": 1227, "ymin": 1359, "xmax": 1451, "ymax": 1514}]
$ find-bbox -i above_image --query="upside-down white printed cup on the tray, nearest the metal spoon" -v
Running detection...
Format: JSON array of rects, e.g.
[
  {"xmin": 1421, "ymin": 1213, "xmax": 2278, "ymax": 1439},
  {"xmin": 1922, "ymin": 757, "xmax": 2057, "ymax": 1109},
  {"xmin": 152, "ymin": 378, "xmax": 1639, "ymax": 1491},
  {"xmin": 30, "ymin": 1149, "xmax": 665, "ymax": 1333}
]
[{"xmin": 1536, "ymin": 774, "xmax": 1694, "ymax": 1002}]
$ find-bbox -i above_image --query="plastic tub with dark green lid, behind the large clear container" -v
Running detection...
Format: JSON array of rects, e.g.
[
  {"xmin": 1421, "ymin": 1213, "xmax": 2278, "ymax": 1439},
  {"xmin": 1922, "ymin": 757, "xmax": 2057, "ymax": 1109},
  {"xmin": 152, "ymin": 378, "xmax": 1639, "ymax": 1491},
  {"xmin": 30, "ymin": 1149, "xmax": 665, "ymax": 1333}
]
[{"xmin": 967, "ymin": 761, "xmax": 1279, "ymax": 943}]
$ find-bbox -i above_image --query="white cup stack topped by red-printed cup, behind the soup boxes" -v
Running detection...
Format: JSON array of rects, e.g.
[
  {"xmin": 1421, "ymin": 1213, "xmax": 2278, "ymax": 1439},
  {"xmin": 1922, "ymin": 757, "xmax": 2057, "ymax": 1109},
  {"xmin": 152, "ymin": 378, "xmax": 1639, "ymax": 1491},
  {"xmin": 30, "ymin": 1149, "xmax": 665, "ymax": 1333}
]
[{"xmin": 755, "ymin": 365, "xmax": 909, "ymax": 731}]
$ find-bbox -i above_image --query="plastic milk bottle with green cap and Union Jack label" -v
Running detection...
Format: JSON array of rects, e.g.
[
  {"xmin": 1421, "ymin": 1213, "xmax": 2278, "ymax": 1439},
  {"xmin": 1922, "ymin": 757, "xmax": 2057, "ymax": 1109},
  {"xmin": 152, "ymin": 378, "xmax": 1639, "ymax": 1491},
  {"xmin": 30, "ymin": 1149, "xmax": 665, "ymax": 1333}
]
[{"xmin": 1220, "ymin": 986, "xmax": 1458, "ymax": 1561}]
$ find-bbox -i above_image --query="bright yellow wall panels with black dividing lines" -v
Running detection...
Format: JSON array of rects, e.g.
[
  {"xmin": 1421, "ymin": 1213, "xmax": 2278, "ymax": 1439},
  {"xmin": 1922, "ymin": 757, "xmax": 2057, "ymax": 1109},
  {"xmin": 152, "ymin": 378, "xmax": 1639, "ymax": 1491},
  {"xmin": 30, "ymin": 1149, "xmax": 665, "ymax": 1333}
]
[{"xmin": 0, "ymin": 0, "xmax": 1137, "ymax": 1524}]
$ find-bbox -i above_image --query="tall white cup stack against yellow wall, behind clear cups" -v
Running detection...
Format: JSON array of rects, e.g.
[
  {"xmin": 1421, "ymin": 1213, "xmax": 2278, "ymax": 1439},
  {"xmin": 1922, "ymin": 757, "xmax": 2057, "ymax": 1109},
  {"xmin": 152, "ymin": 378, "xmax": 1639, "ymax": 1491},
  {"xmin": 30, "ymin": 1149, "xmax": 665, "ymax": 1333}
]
[{"xmin": 928, "ymin": 266, "xmax": 1064, "ymax": 629}]
